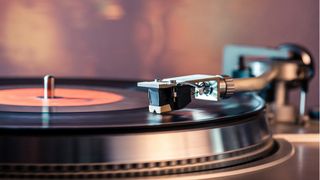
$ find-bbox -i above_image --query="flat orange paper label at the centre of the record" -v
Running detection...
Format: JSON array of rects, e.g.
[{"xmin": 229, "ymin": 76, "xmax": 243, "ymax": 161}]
[{"xmin": 0, "ymin": 88, "xmax": 124, "ymax": 106}]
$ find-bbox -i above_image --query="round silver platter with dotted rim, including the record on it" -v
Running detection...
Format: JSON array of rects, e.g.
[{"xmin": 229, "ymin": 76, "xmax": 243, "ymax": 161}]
[{"xmin": 0, "ymin": 79, "xmax": 277, "ymax": 178}]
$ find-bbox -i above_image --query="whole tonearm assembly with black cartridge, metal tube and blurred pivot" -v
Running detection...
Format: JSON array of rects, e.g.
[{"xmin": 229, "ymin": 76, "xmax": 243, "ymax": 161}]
[{"xmin": 138, "ymin": 44, "xmax": 314, "ymax": 123}]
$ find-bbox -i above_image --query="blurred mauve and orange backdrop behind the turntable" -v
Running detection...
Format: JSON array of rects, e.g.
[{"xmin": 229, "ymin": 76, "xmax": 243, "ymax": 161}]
[{"xmin": 0, "ymin": 0, "xmax": 319, "ymax": 106}]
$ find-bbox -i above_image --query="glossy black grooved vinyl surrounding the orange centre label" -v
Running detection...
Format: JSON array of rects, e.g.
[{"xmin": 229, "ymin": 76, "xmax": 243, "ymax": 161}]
[{"xmin": 0, "ymin": 79, "xmax": 264, "ymax": 132}]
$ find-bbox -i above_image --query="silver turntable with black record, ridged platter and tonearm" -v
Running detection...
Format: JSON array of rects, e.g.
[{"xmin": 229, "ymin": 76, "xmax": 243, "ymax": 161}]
[{"xmin": 0, "ymin": 45, "xmax": 316, "ymax": 179}]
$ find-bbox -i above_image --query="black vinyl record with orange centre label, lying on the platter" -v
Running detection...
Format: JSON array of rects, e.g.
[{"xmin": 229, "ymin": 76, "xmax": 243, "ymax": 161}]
[{"xmin": 0, "ymin": 79, "xmax": 264, "ymax": 131}]
